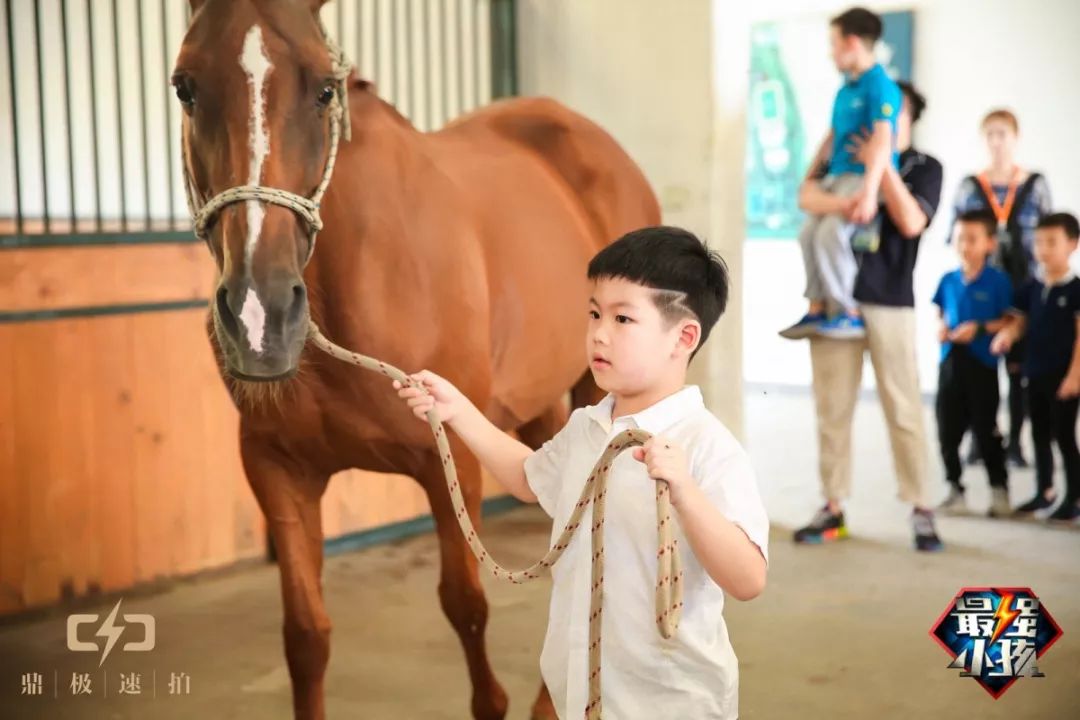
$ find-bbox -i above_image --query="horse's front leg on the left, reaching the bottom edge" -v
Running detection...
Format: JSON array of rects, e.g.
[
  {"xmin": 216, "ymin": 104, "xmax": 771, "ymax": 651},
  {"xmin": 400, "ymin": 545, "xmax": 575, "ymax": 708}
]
[{"xmin": 242, "ymin": 443, "xmax": 330, "ymax": 720}]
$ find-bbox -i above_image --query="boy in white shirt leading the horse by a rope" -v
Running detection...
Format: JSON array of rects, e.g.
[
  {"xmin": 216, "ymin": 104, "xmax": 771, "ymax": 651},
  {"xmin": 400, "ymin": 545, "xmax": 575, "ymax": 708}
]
[{"xmin": 394, "ymin": 227, "xmax": 769, "ymax": 720}]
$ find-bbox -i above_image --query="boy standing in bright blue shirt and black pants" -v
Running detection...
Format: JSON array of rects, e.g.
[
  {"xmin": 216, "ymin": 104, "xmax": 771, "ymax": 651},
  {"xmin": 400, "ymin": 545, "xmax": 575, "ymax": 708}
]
[{"xmin": 934, "ymin": 210, "xmax": 1012, "ymax": 517}]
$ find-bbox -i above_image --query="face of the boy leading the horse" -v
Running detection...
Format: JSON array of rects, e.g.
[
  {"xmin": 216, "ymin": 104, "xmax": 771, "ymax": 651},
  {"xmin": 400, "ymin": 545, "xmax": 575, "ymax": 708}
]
[{"xmin": 585, "ymin": 279, "xmax": 701, "ymax": 395}]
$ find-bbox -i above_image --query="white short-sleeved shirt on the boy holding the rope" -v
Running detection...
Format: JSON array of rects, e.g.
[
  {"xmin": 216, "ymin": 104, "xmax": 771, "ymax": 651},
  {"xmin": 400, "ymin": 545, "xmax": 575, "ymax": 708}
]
[{"xmin": 525, "ymin": 385, "xmax": 769, "ymax": 720}]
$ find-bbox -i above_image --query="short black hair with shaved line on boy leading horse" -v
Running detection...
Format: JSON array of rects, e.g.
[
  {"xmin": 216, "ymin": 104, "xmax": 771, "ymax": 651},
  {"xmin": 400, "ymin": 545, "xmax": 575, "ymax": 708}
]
[{"xmin": 589, "ymin": 226, "xmax": 728, "ymax": 359}]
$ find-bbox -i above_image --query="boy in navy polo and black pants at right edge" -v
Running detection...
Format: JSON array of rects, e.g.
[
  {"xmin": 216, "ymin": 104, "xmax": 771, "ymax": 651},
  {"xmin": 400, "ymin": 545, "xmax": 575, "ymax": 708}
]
[{"xmin": 993, "ymin": 213, "xmax": 1080, "ymax": 522}]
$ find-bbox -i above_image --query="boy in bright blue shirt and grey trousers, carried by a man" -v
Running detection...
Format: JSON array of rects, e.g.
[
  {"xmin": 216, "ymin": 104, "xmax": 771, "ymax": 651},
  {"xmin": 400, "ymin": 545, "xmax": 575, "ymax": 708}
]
[{"xmin": 780, "ymin": 8, "xmax": 901, "ymax": 340}]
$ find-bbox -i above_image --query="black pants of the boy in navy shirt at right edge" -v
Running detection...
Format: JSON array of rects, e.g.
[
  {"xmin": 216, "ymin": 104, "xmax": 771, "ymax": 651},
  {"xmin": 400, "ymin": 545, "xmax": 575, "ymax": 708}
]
[{"xmin": 1027, "ymin": 372, "xmax": 1080, "ymax": 501}]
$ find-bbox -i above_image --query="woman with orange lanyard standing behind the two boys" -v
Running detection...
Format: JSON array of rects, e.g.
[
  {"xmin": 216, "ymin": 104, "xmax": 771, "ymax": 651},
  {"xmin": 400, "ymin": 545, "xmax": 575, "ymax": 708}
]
[{"xmin": 946, "ymin": 109, "xmax": 1051, "ymax": 467}]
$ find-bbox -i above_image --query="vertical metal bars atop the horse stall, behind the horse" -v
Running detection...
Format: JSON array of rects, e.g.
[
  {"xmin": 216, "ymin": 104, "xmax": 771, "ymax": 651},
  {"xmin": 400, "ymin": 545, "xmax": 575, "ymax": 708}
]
[{"xmin": 0, "ymin": 0, "xmax": 516, "ymax": 248}]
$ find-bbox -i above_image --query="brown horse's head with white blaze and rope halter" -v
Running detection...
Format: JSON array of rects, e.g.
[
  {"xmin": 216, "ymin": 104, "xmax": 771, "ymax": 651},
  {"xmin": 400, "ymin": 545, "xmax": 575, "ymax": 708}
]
[{"xmin": 173, "ymin": 0, "xmax": 343, "ymax": 381}]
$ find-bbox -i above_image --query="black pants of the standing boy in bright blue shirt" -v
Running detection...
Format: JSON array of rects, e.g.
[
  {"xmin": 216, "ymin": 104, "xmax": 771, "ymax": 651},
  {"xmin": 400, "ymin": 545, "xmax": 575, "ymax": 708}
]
[{"xmin": 937, "ymin": 345, "xmax": 1008, "ymax": 488}]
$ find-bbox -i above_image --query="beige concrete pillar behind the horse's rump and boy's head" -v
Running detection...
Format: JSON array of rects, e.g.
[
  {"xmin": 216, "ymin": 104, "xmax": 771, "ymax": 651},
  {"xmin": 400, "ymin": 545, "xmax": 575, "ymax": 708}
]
[{"xmin": 517, "ymin": 0, "xmax": 750, "ymax": 435}]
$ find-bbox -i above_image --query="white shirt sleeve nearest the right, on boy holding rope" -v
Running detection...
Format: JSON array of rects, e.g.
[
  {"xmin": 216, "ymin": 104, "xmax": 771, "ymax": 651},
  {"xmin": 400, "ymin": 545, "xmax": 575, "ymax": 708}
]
[{"xmin": 693, "ymin": 439, "xmax": 769, "ymax": 565}]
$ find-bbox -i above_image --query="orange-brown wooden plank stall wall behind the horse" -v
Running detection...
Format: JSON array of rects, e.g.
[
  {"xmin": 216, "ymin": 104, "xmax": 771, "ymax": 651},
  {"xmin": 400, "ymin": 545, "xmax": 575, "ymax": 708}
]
[{"xmin": 0, "ymin": 244, "xmax": 507, "ymax": 614}]
